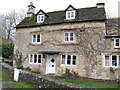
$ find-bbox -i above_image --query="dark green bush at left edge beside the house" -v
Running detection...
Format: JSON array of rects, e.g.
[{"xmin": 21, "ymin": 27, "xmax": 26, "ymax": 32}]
[{"xmin": 0, "ymin": 43, "xmax": 14, "ymax": 59}]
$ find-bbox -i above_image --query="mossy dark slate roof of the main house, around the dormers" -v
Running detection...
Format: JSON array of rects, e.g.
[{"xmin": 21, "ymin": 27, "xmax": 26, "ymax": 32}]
[{"xmin": 16, "ymin": 7, "xmax": 106, "ymax": 28}]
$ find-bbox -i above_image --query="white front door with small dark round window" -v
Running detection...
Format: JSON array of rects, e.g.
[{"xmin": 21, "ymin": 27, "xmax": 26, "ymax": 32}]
[{"xmin": 46, "ymin": 55, "xmax": 56, "ymax": 74}]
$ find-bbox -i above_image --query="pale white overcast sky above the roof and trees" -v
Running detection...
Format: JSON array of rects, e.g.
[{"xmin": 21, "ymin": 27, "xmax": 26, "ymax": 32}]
[{"xmin": 0, "ymin": 0, "xmax": 120, "ymax": 17}]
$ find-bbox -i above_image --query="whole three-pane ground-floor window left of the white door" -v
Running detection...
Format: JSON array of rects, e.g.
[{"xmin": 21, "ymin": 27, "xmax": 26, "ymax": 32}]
[{"xmin": 29, "ymin": 54, "xmax": 42, "ymax": 64}]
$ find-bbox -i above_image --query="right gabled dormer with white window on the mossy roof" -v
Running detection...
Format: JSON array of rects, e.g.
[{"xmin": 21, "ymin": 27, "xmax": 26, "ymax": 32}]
[{"xmin": 65, "ymin": 5, "xmax": 76, "ymax": 20}]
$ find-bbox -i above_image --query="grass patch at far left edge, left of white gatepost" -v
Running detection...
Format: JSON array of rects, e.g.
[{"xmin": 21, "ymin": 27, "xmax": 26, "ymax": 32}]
[{"xmin": 0, "ymin": 66, "xmax": 10, "ymax": 81}]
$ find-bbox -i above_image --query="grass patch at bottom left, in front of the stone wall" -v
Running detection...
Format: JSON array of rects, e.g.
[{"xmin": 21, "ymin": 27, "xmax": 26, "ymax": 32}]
[{"xmin": 5, "ymin": 82, "xmax": 34, "ymax": 88}]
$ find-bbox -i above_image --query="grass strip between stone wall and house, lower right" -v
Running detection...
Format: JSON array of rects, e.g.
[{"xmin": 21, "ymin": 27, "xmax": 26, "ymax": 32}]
[{"xmin": 61, "ymin": 79, "xmax": 118, "ymax": 88}]
